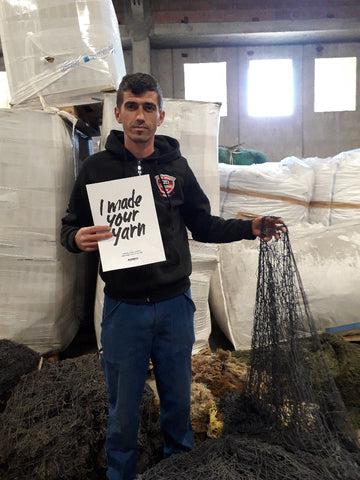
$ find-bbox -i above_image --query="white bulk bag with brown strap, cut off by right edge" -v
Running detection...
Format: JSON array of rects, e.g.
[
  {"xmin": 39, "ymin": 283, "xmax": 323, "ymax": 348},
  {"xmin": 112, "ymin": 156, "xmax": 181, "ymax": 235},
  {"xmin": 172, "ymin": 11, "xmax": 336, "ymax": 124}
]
[{"xmin": 305, "ymin": 149, "xmax": 360, "ymax": 225}]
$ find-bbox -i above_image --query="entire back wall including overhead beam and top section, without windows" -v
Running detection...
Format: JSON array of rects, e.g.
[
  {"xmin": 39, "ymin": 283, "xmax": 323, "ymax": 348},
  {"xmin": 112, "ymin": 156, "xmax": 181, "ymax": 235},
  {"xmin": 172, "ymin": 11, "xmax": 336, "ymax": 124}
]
[{"xmin": 0, "ymin": 0, "xmax": 360, "ymax": 161}]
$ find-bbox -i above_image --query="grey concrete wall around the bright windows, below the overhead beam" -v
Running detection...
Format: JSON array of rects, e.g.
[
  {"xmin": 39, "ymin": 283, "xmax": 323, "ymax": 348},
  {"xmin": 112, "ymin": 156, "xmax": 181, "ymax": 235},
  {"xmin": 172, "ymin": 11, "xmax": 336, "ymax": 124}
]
[{"xmin": 151, "ymin": 43, "xmax": 360, "ymax": 161}]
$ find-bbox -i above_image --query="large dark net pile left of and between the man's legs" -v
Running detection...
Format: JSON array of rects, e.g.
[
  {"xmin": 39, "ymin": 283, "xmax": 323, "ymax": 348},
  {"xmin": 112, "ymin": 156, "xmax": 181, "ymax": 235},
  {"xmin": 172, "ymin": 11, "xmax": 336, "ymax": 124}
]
[{"xmin": 0, "ymin": 348, "xmax": 161, "ymax": 480}]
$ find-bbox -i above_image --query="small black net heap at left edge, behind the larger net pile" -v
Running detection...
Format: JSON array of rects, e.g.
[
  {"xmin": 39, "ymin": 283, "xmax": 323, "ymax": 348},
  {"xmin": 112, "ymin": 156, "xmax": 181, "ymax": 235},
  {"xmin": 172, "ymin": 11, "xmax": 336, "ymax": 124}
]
[{"xmin": 0, "ymin": 339, "xmax": 40, "ymax": 412}]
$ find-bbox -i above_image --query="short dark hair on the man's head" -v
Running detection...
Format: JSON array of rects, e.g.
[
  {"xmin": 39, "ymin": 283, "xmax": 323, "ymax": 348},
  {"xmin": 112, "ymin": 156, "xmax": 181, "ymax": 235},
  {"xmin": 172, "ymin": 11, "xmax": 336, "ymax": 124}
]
[{"xmin": 116, "ymin": 73, "xmax": 163, "ymax": 111}]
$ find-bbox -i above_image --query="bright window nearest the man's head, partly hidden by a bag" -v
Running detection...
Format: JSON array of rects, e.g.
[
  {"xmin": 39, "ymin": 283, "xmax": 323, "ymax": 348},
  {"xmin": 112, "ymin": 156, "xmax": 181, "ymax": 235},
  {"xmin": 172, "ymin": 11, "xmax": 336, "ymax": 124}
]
[{"xmin": 184, "ymin": 62, "xmax": 227, "ymax": 117}]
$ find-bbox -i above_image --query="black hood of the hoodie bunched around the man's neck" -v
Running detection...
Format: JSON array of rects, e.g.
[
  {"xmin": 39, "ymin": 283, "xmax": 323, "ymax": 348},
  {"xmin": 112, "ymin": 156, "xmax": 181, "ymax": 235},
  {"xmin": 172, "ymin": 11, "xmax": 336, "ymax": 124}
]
[{"xmin": 105, "ymin": 130, "xmax": 181, "ymax": 164}]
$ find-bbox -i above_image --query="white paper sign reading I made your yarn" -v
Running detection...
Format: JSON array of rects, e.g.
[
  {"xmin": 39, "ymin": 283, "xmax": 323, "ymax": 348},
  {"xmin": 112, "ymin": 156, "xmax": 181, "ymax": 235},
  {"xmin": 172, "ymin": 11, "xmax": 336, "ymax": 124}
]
[{"xmin": 86, "ymin": 175, "xmax": 166, "ymax": 272}]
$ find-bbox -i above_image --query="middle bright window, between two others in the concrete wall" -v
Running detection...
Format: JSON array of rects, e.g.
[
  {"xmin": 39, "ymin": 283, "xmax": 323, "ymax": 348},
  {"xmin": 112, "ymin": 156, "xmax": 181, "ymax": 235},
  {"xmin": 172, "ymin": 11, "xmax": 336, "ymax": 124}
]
[{"xmin": 248, "ymin": 58, "xmax": 294, "ymax": 117}]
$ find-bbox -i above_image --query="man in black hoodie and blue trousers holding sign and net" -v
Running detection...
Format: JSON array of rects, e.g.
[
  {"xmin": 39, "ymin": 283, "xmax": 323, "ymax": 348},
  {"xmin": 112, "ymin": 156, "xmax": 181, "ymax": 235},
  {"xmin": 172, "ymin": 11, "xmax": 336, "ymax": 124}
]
[{"xmin": 61, "ymin": 73, "xmax": 285, "ymax": 480}]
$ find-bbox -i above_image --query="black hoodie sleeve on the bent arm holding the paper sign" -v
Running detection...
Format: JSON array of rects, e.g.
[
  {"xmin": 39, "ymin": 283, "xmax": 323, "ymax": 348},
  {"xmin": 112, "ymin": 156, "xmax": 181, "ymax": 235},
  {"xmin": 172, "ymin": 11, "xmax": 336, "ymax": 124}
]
[{"xmin": 60, "ymin": 167, "xmax": 93, "ymax": 253}]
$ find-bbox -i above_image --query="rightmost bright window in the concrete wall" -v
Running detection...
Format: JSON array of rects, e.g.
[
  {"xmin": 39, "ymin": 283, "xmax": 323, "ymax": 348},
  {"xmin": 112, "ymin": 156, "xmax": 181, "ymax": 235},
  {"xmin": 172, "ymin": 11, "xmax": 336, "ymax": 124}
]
[{"xmin": 314, "ymin": 57, "xmax": 356, "ymax": 112}]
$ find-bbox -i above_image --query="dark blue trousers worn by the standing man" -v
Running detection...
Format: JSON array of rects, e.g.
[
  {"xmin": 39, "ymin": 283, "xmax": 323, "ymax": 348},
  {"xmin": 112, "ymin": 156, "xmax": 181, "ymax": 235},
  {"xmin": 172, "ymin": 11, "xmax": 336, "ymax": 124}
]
[{"xmin": 101, "ymin": 290, "xmax": 195, "ymax": 480}]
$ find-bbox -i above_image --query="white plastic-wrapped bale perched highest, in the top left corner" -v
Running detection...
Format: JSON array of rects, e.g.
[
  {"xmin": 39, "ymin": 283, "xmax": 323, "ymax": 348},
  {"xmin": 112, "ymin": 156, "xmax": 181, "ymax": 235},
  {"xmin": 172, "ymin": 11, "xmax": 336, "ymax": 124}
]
[{"xmin": 0, "ymin": 0, "xmax": 125, "ymax": 106}]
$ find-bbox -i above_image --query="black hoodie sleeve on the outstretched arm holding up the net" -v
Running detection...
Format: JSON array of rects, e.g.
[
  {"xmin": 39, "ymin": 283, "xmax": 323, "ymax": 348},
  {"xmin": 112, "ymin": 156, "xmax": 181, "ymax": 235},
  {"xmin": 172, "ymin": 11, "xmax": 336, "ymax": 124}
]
[{"xmin": 182, "ymin": 165, "xmax": 256, "ymax": 243}]
